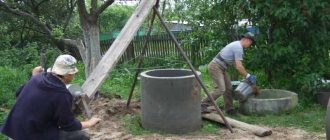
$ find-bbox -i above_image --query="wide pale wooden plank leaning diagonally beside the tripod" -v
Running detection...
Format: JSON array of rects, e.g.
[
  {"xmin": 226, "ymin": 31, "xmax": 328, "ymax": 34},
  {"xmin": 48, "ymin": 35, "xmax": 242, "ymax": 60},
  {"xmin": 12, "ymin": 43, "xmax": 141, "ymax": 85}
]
[{"xmin": 82, "ymin": 0, "xmax": 156, "ymax": 98}]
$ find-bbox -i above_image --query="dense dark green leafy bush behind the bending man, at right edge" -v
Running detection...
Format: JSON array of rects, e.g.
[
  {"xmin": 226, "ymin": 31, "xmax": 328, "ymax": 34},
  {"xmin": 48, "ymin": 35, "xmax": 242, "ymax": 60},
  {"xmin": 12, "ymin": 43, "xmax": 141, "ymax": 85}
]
[{"xmin": 248, "ymin": 0, "xmax": 330, "ymax": 104}]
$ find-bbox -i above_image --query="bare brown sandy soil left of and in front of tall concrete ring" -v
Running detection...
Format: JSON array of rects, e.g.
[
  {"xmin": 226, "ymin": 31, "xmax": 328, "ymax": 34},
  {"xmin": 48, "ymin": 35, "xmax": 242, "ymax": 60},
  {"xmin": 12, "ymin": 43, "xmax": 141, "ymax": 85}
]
[{"xmin": 86, "ymin": 97, "xmax": 326, "ymax": 140}]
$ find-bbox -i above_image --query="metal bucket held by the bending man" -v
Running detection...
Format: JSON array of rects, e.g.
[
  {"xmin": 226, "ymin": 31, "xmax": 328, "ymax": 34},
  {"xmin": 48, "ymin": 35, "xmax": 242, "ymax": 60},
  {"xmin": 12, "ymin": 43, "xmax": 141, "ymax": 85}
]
[{"xmin": 234, "ymin": 80, "xmax": 253, "ymax": 102}]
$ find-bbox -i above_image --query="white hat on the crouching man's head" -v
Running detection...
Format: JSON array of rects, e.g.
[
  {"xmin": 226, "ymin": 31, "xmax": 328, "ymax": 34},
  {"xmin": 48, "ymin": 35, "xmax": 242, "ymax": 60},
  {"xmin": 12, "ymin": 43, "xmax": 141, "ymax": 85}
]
[{"xmin": 51, "ymin": 54, "xmax": 78, "ymax": 75}]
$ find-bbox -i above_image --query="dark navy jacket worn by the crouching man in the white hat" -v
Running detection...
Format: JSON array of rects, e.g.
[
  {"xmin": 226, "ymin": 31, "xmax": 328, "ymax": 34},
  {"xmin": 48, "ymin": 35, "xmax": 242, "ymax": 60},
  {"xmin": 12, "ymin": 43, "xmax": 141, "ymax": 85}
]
[{"xmin": 1, "ymin": 73, "xmax": 81, "ymax": 140}]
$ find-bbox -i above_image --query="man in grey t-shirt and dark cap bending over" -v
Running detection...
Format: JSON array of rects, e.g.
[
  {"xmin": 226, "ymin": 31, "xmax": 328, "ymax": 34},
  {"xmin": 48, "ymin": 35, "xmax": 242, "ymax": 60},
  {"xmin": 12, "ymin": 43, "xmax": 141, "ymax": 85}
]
[{"xmin": 202, "ymin": 32, "xmax": 256, "ymax": 115}]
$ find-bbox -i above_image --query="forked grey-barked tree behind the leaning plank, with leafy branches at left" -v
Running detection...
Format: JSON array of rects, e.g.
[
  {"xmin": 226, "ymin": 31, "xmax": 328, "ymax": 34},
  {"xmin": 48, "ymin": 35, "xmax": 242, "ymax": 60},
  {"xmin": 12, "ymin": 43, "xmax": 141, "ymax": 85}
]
[{"xmin": 0, "ymin": 0, "xmax": 114, "ymax": 77}]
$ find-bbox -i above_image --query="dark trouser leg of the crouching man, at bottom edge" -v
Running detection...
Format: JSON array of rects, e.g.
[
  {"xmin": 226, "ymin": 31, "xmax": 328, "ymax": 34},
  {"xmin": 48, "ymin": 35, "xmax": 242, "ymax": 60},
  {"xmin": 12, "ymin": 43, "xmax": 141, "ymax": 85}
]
[{"xmin": 59, "ymin": 130, "xmax": 90, "ymax": 140}]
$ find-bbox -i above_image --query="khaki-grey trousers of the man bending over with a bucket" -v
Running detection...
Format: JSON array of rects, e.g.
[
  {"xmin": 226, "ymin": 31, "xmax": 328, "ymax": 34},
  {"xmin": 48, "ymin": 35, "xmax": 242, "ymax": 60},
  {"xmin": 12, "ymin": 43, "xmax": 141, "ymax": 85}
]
[{"xmin": 202, "ymin": 61, "xmax": 233, "ymax": 111}]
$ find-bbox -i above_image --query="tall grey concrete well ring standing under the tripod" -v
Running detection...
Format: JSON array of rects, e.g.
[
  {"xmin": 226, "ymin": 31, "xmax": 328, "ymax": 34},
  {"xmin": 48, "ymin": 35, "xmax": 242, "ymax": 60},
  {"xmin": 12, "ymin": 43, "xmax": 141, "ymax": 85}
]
[{"xmin": 141, "ymin": 69, "xmax": 202, "ymax": 134}]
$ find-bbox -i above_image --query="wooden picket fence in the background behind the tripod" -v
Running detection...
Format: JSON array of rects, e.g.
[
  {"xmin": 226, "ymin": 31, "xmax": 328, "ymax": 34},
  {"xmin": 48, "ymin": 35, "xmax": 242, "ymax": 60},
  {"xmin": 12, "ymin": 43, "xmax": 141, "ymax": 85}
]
[{"xmin": 101, "ymin": 33, "xmax": 205, "ymax": 64}]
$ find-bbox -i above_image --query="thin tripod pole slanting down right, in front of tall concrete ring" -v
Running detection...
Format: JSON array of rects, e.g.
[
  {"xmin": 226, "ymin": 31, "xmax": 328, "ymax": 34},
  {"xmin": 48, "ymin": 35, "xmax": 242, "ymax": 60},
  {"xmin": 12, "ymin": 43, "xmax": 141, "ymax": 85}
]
[{"xmin": 154, "ymin": 7, "xmax": 234, "ymax": 133}]
